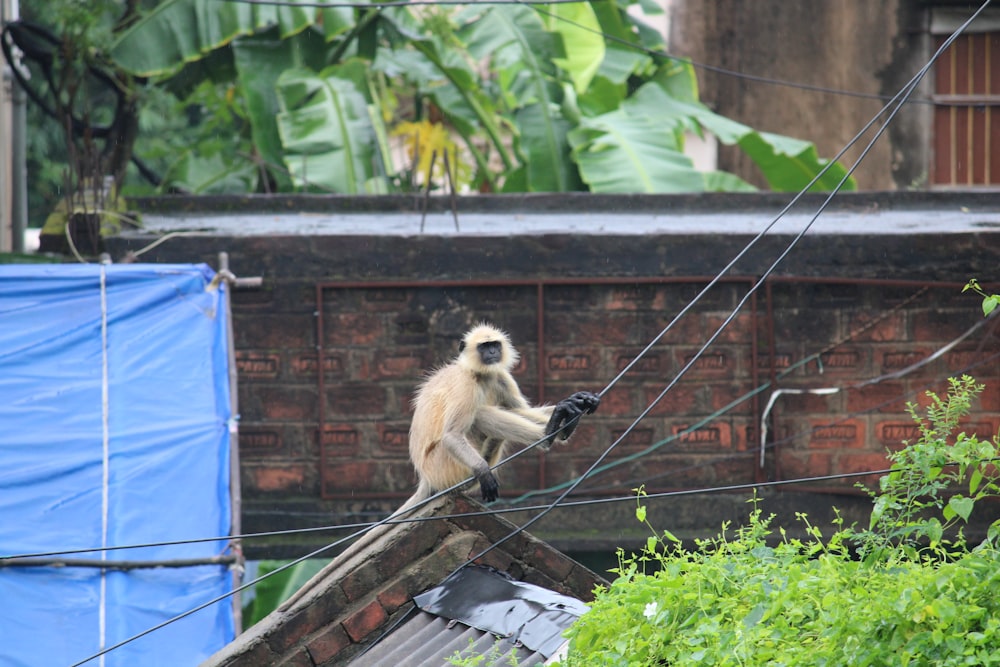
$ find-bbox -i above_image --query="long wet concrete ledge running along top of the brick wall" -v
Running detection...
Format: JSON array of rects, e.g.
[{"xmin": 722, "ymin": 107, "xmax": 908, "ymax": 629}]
[{"xmin": 122, "ymin": 192, "xmax": 1000, "ymax": 238}]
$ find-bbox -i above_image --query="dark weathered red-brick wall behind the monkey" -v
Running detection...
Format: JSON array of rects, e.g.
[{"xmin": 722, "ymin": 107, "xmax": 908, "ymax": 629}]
[{"xmin": 110, "ymin": 194, "xmax": 1000, "ymax": 555}]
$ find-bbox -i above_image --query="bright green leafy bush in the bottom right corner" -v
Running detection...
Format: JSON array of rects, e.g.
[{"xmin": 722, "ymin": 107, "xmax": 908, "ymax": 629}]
[{"xmin": 560, "ymin": 377, "xmax": 1000, "ymax": 667}]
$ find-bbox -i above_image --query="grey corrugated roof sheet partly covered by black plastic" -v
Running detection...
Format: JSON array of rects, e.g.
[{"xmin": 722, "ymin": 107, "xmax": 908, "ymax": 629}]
[{"xmin": 351, "ymin": 567, "xmax": 587, "ymax": 667}]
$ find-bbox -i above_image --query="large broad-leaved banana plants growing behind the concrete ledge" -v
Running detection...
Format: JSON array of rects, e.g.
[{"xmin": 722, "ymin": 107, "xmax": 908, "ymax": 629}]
[{"xmin": 21, "ymin": 0, "xmax": 855, "ymax": 206}]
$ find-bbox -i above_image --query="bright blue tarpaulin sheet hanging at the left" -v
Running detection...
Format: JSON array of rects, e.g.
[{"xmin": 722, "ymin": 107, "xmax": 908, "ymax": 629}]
[{"xmin": 0, "ymin": 264, "xmax": 234, "ymax": 667}]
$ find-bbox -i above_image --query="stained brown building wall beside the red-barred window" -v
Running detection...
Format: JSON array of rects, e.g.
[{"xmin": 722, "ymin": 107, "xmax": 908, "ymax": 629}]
[{"xmin": 670, "ymin": 0, "xmax": 932, "ymax": 190}]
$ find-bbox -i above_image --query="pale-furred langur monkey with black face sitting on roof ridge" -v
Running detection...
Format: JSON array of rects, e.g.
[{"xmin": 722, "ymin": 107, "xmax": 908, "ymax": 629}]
[{"xmin": 281, "ymin": 324, "xmax": 601, "ymax": 609}]
